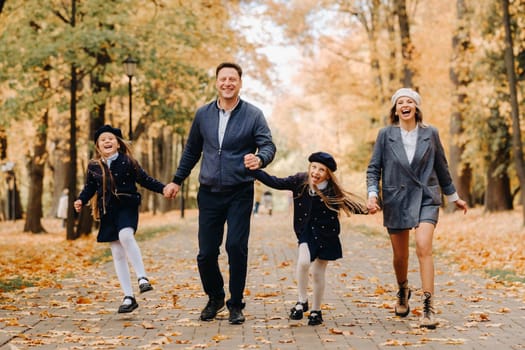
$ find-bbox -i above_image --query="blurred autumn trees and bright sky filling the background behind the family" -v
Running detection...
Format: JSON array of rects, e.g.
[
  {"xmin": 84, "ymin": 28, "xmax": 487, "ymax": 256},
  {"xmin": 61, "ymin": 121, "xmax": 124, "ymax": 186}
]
[{"xmin": 0, "ymin": 0, "xmax": 525, "ymax": 239}]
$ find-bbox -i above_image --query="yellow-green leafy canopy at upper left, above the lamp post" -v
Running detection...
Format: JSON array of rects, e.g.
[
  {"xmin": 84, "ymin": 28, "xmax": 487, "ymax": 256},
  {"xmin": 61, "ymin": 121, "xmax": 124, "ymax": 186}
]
[{"xmin": 0, "ymin": 0, "xmax": 270, "ymax": 130}]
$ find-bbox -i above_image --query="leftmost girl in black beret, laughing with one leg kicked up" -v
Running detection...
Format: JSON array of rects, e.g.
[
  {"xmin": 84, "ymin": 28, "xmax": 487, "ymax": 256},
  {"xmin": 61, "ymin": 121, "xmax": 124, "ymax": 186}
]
[{"xmin": 74, "ymin": 125, "xmax": 164, "ymax": 313}]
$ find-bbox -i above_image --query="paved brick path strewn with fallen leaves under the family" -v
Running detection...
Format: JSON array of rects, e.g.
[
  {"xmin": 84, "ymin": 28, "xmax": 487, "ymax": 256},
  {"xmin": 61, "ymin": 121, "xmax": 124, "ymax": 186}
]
[{"xmin": 0, "ymin": 209, "xmax": 525, "ymax": 350}]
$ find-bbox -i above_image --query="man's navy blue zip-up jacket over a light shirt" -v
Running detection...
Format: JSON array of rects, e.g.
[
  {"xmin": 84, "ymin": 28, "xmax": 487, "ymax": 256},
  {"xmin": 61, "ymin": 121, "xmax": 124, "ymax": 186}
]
[{"xmin": 173, "ymin": 99, "xmax": 276, "ymax": 191}]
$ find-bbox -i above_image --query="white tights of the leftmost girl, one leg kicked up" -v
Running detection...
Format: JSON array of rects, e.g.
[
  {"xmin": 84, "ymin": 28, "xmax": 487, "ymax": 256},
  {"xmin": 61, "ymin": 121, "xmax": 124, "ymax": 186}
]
[{"xmin": 111, "ymin": 227, "xmax": 146, "ymax": 296}]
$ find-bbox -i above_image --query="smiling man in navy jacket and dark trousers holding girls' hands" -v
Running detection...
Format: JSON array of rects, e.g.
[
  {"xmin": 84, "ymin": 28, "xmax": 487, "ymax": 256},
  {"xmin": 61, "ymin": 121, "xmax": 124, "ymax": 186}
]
[{"xmin": 164, "ymin": 62, "xmax": 275, "ymax": 324}]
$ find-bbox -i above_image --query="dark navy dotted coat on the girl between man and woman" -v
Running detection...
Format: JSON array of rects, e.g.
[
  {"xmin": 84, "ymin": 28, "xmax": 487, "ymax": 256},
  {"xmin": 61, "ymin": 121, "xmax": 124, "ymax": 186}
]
[{"xmin": 253, "ymin": 170, "xmax": 343, "ymax": 261}]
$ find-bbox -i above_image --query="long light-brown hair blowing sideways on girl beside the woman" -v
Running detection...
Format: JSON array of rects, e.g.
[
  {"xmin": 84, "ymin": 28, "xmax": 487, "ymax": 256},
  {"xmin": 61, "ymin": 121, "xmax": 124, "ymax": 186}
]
[{"xmin": 299, "ymin": 167, "xmax": 368, "ymax": 216}]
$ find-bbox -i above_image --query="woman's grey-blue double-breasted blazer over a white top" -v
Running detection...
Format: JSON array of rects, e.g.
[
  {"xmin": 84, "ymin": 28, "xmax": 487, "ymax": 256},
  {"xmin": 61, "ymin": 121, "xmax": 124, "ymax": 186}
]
[{"xmin": 366, "ymin": 125, "xmax": 456, "ymax": 229}]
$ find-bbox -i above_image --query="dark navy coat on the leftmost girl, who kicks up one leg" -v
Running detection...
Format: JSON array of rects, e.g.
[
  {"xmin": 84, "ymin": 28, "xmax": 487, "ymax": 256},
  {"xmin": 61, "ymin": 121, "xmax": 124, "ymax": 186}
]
[{"xmin": 78, "ymin": 153, "xmax": 164, "ymax": 242}]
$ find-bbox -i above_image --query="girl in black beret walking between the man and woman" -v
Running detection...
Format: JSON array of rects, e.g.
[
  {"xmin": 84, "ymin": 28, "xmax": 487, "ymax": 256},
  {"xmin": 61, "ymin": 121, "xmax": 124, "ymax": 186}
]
[{"xmin": 249, "ymin": 152, "xmax": 367, "ymax": 326}]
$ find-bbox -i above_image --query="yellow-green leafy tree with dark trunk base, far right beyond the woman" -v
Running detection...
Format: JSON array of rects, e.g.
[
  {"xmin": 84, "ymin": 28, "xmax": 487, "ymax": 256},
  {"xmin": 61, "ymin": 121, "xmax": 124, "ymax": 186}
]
[{"xmin": 465, "ymin": 1, "xmax": 519, "ymax": 211}]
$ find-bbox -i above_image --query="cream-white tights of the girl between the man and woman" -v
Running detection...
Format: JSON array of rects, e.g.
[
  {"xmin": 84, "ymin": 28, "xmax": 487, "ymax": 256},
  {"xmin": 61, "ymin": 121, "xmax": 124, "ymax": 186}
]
[{"xmin": 296, "ymin": 243, "xmax": 328, "ymax": 310}]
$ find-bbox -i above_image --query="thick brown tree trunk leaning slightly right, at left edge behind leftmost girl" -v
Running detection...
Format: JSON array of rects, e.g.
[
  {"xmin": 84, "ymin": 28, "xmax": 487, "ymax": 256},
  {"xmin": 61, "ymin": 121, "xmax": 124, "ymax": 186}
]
[{"xmin": 24, "ymin": 110, "xmax": 49, "ymax": 233}]
